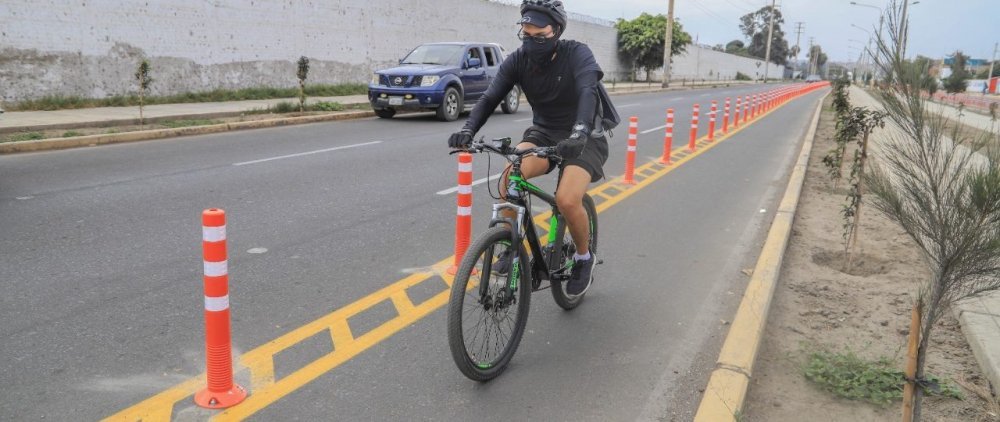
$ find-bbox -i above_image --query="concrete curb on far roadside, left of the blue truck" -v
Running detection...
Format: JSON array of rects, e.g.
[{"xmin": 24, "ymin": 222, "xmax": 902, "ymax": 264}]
[{"xmin": 0, "ymin": 111, "xmax": 375, "ymax": 154}]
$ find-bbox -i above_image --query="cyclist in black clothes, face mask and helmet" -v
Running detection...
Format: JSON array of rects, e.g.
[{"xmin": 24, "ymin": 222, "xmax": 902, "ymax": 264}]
[{"xmin": 448, "ymin": 0, "xmax": 610, "ymax": 295}]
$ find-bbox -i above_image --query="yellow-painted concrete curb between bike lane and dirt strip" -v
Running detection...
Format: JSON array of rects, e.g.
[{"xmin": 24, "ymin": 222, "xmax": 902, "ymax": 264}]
[{"xmin": 694, "ymin": 92, "xmax": 829, "ymax": 422}]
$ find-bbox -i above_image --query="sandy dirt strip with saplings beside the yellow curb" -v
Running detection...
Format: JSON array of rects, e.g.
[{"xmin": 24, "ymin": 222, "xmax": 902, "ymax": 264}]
[{"xmin": 740, "ymin": 96, "xmax": 1000, "ymax": 422}]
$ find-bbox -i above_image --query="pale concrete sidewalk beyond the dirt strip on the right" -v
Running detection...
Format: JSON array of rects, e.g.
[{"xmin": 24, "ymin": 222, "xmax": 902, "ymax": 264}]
[{"xmin": 850, "ymin": 86, "xmax": 1000, "ymax": 396}]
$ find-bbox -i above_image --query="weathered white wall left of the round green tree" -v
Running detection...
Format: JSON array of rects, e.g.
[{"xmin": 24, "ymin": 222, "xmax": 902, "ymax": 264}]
[{"xmin": 0, "ymin": 0, "xmax": 620, "ymax": 101}]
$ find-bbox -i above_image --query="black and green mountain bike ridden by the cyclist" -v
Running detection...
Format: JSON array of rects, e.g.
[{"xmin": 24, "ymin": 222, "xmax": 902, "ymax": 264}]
[{"xmin": 448, "ymin": 138, "xmax": 601, "ymax": 381}]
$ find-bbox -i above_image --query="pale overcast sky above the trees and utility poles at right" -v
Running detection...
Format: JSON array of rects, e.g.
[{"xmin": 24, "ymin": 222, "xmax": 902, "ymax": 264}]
[{"xmin": 564, "ymin": 0, "xmax": 1000, "ymax": 61}]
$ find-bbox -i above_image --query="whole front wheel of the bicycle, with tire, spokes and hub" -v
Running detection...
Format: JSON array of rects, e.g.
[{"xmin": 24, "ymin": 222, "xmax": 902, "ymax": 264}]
[{"xmin": 448, "ymin": 226, "xmax": 531, "ymax": 381}]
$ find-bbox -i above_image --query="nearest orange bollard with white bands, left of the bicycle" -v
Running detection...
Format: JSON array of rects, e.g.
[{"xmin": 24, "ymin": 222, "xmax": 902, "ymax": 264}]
[{"xmin": 194, "ymin": 208, "xmax": 247, "ymax": 409}]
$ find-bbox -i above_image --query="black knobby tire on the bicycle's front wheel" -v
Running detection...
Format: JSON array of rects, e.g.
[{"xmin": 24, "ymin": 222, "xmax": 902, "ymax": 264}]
[{"xmin": 448, "ymin": 226, "xmax": 531, "ymax": 382}]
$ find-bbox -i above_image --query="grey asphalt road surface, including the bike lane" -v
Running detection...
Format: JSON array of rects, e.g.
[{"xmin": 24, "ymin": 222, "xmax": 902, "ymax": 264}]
[{"xmin": 0, "ymin": 86, "xmax": 820, "ymax": 420}]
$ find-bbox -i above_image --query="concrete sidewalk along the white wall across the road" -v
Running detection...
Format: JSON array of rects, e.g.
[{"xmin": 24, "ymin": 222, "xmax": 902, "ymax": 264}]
[{"xmin": 0, "ymin": 81, "xmax": 748, "ymax": 134}]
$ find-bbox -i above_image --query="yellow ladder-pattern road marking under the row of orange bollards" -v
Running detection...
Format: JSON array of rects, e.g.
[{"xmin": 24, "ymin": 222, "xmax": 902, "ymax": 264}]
[{"xmin": 104, "ymin": 87, "xmax": 820, "ymax": 422}]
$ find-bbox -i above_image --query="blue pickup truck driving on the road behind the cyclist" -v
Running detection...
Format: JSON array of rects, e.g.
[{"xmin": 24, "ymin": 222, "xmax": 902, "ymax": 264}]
[{"xmin": 368, "ymin": 42, "xmax": 521, "ymax": 122}]
